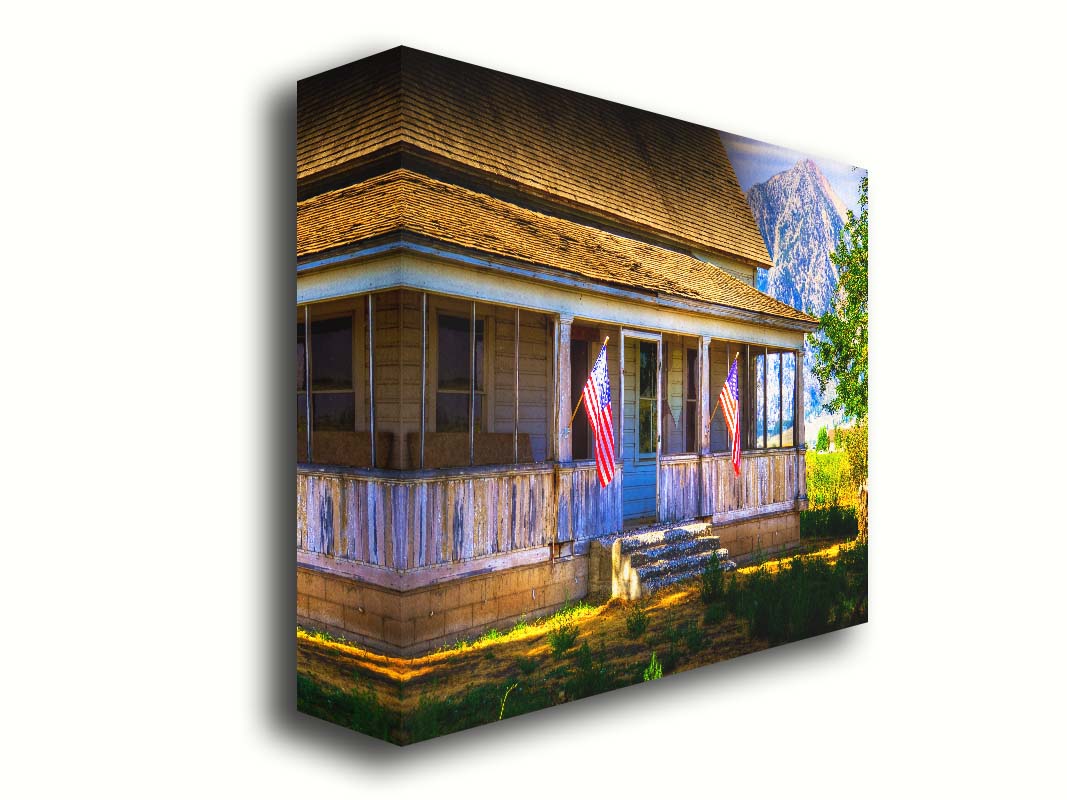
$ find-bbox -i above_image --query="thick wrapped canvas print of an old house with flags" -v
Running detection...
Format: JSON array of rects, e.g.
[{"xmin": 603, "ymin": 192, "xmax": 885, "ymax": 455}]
[{"xmin": 294, "ymin": 47, "xmax": 869, "ymax": 745}]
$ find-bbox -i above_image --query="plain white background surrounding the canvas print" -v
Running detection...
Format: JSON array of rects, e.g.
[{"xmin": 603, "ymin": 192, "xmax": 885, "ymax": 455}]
[{"xmin": 0, "ymin": 2, "xmax": 1067, "ymax": 798}]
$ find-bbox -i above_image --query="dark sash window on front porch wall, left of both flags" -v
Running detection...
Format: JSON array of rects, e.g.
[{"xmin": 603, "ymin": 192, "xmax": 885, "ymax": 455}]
[{"xmin": 436, "ymin": 314, "xmax": 485, "ymax": 433}]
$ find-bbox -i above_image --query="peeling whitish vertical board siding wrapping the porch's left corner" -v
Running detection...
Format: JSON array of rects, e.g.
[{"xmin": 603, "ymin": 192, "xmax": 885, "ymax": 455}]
[{"xmin": 297, "ymin": 467, "xmax": 554, "ymax": 570}]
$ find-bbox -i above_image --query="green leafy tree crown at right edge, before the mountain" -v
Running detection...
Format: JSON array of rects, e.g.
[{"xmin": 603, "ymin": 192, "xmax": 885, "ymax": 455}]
[{"xmin": 808, "ymin": 175, "xmax": 867, "ymax": 419}]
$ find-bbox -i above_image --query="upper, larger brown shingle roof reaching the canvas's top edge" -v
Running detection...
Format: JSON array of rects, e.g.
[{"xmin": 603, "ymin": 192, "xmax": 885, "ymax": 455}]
[{"xmin": 297, "ymin": 47, "xmax": 771, "ymax": 268}]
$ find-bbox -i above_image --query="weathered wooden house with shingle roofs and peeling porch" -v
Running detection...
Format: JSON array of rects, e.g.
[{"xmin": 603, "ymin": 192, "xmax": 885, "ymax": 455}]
[{"xmin": 296, "ymin": 48, "xmax": 815, "ymax": 654}]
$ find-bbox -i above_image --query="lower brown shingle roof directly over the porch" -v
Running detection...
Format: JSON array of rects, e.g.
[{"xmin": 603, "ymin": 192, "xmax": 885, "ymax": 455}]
[{"xmin": 297, "ymin": 170, "xmax": 816, "ymax": 322}]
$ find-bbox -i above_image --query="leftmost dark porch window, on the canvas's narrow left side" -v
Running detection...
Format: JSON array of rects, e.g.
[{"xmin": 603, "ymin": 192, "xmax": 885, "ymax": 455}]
[{"xmin": 307, "ymin": 317, "xmax": 355, "ymax": 431}]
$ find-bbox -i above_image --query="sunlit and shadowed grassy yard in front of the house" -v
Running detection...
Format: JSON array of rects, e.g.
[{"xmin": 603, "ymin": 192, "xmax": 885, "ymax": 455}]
[{"xmin": 297, "ymin": 539, "xmax": 867, "ymax": 743}]
